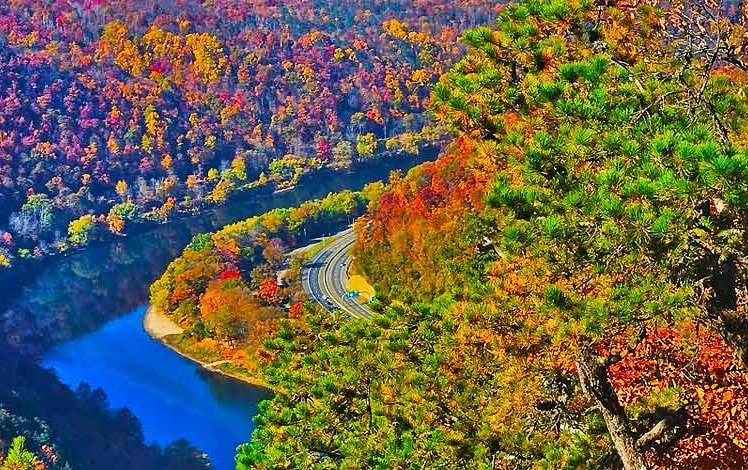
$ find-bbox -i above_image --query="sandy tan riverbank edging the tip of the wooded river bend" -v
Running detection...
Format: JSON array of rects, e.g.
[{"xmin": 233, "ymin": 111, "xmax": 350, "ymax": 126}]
[{"xmin": 143, "ymin": 306, "xmax": 270, "ymax": 389}]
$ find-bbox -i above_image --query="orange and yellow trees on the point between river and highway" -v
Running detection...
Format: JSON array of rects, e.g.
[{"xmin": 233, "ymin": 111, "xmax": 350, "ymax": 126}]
[{"xmin": 151, "ymin": 191, "xmax": 368, "ymax": 379}]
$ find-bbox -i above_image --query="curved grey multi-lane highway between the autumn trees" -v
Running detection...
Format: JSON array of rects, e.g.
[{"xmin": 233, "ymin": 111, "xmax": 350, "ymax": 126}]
[{"xmin": 301, "ymin": 228, "xmax": 371, "ymax": 318}]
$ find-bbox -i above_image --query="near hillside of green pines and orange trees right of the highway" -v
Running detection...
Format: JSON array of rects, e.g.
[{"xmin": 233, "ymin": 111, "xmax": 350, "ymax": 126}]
[{"xmin": 244, "ymin": 0, "xmax": 748, "ymax": 470}]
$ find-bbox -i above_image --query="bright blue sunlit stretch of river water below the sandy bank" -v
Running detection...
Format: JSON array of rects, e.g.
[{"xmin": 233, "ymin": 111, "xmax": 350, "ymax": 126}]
[{"xmin": 42, "ymin": 308, "xmax": 269, "ymax": 470}]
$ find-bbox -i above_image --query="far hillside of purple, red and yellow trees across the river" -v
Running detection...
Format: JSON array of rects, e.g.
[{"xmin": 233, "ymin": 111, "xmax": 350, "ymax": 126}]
[{"xmin": 0, "ymin": 0, "xmax": 495, "ymax": 269}]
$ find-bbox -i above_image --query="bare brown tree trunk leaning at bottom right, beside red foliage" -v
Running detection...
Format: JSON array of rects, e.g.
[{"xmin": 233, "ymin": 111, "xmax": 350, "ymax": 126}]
[{"xmin": 577, "ymin": 352, "xmax": 647, "ymax": 470}]
